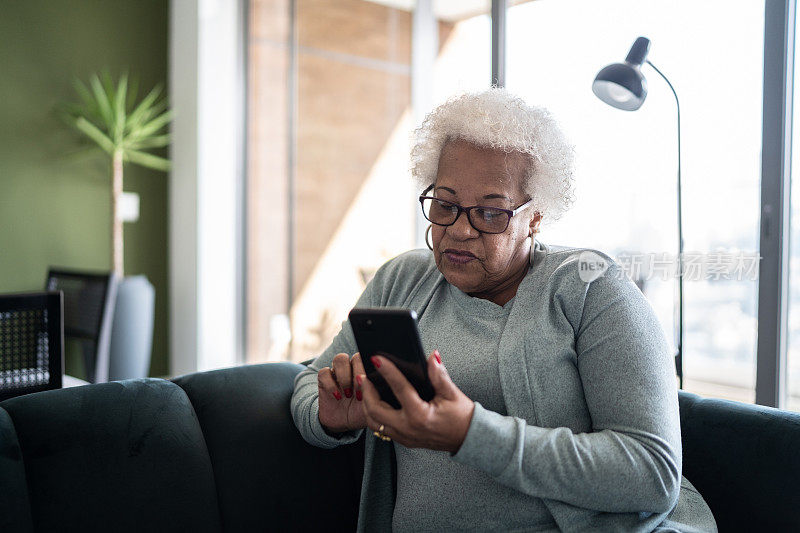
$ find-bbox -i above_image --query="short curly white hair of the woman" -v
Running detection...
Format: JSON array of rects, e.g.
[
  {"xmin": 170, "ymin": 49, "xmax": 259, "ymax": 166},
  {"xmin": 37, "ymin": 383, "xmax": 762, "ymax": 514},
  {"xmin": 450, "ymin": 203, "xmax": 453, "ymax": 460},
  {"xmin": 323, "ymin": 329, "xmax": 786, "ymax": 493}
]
[{"xmin": 411, "ymin": 87, "xmax": 575, "ymax": 224}]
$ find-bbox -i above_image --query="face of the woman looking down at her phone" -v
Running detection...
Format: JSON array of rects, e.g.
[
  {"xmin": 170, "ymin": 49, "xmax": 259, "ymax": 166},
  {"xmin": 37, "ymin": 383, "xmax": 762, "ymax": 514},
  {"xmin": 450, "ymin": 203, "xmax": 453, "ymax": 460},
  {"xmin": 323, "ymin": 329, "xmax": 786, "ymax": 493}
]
[{"xmin": 428, "ymin": 140, "xmax": 541, "ymax": 305}]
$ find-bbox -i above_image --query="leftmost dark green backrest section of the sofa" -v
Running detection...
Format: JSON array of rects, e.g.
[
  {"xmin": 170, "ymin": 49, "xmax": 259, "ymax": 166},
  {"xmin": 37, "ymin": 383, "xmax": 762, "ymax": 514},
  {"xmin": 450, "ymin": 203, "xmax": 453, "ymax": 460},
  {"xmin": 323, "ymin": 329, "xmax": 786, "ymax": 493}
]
[{"xmin": 0, "ymin": 379, "xmax": 220, "ymax": 532}]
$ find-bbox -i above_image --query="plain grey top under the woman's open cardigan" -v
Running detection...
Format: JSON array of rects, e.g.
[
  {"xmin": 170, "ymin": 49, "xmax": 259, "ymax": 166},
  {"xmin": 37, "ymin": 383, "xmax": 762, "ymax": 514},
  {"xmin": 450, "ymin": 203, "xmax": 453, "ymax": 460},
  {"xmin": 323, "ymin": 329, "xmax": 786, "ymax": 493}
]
[{"xmin": 392, "ymin": 283, "xmax": 556, "ymax": 533}]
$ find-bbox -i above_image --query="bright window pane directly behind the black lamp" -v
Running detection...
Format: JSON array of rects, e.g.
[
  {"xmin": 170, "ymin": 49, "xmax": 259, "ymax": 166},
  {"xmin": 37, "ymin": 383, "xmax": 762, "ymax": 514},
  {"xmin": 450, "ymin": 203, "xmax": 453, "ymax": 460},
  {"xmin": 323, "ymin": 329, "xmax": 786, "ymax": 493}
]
[{"xmin": 506, "ymin": 0, "xmax": 764, "ymax": 402}]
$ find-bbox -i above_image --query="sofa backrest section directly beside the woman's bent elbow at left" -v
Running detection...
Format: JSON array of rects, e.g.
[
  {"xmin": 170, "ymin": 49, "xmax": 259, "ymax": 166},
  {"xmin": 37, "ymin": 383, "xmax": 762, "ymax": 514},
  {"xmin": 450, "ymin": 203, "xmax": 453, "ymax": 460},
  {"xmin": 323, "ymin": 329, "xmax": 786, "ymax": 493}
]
[{"xmin": 173, "ymin": 363, "xmax": 364, "ymax": 532}]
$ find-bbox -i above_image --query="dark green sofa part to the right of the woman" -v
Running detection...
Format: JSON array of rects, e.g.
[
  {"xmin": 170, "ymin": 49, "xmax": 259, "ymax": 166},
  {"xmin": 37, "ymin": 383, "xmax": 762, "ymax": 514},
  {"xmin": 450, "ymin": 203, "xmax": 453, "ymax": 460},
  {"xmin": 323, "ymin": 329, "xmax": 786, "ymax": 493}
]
[{"xmin": 679, "ymin": 391, "xmax": 800, "ymax": 531}]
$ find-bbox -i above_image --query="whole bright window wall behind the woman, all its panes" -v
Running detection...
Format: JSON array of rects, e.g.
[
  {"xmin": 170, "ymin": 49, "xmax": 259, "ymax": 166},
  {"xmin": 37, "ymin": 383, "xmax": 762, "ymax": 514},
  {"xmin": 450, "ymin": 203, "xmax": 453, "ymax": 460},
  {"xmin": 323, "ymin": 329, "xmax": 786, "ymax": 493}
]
[{"xmin": 246, "ymin": 0, "xmax": 800, "ymax": 409}]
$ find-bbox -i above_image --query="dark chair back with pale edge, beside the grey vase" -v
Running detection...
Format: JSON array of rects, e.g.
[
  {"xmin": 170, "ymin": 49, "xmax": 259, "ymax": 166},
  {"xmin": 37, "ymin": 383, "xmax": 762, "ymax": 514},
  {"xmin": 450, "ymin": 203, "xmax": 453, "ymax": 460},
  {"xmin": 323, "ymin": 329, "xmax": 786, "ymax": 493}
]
[{"xmin": 45, "ymin": 268, "xmax": 118, "ymax": 383}]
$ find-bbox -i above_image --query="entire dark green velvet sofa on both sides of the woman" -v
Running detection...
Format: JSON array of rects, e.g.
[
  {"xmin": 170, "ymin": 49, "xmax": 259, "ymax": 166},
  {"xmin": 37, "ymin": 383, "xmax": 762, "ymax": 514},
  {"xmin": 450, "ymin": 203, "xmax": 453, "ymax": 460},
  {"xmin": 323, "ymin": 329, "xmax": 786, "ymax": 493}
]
[{"xmin": 0, "ymin": 363, "xmax": 800, "ymax": 532}]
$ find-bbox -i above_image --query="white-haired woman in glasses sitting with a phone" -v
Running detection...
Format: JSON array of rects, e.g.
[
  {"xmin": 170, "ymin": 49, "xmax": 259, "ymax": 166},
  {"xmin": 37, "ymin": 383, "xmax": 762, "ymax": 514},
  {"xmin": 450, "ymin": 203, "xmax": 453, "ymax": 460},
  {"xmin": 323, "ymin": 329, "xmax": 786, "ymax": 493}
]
[{"xmin": 291, "ymin": 89, "xmax": 716, "ymax": 531}]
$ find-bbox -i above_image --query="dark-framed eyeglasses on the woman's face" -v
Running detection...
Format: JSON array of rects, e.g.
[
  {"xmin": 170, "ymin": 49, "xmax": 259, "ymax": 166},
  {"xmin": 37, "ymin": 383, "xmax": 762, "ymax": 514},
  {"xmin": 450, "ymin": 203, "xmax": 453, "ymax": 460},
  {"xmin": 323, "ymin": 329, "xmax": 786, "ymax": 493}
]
[{"xmin": 419, "ymin": 185, "xmax": 533, "ymax": 233}]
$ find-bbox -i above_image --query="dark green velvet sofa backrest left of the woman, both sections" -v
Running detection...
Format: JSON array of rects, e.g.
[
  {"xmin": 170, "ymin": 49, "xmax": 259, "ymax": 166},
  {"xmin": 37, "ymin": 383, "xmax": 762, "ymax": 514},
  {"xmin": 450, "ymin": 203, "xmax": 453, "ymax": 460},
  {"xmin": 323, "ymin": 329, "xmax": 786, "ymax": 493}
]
[{"xmin": 0, "ymin": 363, "xmax": 363, "ymax": 532}]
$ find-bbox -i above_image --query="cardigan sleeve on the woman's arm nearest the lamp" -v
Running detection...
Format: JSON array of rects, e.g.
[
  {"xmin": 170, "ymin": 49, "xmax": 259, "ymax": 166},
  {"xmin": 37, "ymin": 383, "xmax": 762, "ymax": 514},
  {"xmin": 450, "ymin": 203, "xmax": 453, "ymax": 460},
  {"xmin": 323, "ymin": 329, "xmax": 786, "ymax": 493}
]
[{"xmin": 452, "ymin": 263, "xmax": 681, "ymax": 513}]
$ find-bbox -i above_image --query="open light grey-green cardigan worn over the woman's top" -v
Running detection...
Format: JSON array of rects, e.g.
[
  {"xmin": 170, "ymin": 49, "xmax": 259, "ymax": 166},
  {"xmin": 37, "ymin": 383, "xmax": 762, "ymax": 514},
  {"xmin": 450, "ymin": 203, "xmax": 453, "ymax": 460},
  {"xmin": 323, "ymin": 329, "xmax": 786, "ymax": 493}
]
[{"xmin": 291, "ymin": 241, "xmax": 715, "ymax": 531}]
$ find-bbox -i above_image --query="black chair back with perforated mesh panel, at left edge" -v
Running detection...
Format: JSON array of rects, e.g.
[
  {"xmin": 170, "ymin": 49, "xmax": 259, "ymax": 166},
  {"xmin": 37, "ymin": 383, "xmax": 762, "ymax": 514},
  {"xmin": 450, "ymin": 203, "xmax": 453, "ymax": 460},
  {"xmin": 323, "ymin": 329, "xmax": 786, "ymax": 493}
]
[{"xmin": 0, "ymin": 292, "xmax": 64, "ymax": 400}]
